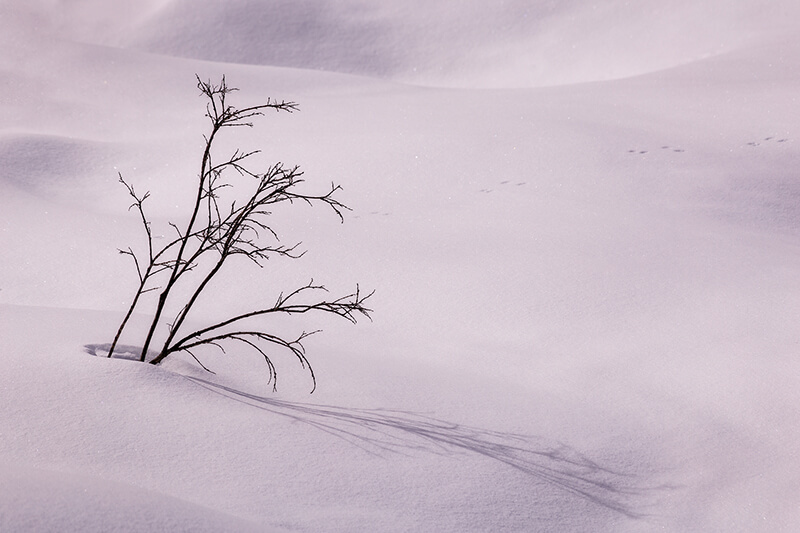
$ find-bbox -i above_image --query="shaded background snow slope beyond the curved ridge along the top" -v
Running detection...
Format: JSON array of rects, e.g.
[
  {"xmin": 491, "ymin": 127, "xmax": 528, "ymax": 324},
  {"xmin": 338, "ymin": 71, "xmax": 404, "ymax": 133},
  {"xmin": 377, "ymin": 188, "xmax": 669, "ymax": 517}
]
[{"xmin": 6, "ymin": 0, "xmax": 800, "ymax": 88}]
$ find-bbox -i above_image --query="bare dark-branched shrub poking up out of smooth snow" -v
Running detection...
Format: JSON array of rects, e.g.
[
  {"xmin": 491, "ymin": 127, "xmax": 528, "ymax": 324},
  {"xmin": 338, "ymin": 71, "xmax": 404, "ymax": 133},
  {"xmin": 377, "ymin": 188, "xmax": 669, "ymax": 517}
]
[{"xmin": 108, "ymin": 77, "xmax": 374, "ymax": 392}]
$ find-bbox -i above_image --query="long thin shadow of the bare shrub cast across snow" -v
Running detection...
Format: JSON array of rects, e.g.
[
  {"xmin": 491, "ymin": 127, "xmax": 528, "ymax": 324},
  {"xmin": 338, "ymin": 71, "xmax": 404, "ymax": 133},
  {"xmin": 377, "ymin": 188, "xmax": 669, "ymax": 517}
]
[{"xmin": 185, "ymin": 376, "xmax": 674, "ymax": 518}]
